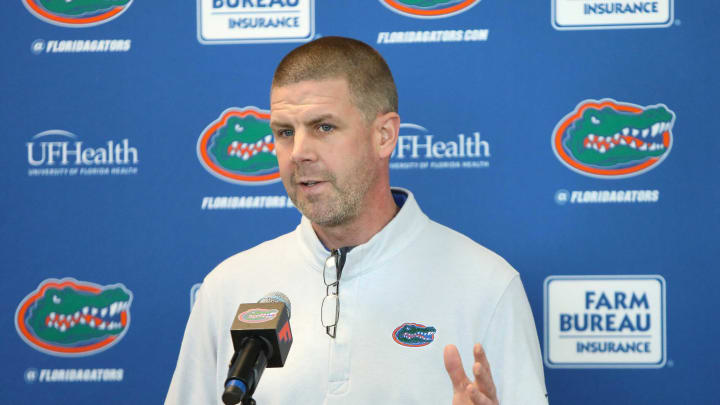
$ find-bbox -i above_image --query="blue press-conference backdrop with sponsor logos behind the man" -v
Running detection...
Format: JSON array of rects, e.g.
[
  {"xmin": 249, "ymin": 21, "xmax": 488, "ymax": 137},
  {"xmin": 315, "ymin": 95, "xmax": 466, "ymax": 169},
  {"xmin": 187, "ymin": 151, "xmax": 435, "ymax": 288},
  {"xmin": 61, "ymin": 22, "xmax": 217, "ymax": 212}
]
[{"xmin": 0, "ymin": 0, "xmax": 720, "ymax": 404}]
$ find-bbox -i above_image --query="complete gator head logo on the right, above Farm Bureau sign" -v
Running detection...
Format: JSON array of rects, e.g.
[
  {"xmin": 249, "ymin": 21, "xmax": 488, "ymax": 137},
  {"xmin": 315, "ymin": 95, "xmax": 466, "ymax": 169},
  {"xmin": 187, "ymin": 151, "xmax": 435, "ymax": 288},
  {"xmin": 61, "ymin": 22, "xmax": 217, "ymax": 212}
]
[{"xmin": 552, "ymin": 99, "xmax": 675, "ymax": 178}]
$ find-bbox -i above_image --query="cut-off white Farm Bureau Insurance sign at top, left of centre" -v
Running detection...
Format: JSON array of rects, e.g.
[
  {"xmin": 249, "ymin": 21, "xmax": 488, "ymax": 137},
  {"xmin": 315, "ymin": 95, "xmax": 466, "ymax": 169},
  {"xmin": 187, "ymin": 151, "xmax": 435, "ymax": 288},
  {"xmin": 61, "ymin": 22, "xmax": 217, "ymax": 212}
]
[{"xmin": 197, "ymin": 0, "xmax": 315, "ymax": 44}]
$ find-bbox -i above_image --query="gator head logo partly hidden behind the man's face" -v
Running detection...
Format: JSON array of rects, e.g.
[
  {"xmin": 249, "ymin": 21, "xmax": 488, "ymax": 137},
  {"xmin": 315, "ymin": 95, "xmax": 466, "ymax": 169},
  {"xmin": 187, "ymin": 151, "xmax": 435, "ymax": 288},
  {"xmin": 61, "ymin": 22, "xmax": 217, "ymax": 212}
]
[{"xmin": 197, "ymin": 107, "xmax": 280, "ymax": 185}]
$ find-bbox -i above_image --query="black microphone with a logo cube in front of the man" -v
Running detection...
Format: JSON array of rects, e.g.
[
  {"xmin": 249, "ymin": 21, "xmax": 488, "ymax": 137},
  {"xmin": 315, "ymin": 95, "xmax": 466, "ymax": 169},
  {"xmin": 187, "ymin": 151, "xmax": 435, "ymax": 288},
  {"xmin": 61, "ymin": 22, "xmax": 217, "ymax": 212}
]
[{"xmin": 222, "ymin": 292, "xmax": 292, "ymax": 405}]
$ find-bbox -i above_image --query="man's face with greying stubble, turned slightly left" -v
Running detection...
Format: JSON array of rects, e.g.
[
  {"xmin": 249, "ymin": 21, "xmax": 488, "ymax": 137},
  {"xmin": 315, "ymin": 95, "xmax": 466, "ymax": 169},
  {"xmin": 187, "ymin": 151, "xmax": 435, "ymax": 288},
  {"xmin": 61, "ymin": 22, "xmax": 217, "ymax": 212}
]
[{"xmin": 270, "ymin": 79, "xmax": 378, "ymax": 226}]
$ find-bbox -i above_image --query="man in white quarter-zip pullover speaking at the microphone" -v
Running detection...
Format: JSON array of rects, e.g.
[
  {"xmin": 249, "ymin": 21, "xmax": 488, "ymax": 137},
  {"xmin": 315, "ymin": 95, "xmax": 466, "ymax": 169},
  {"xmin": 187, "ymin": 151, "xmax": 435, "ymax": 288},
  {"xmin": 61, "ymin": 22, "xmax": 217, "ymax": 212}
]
[{"xmin": 166, "ymin": 37, "xmax": 547, "ymax": 405}]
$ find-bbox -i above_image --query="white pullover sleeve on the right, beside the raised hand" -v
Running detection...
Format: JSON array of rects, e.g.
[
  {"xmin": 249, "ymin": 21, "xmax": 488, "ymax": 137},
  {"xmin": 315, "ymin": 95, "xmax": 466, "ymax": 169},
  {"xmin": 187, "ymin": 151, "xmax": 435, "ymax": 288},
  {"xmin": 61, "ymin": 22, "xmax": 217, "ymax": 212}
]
[{"xmin": 482, "ymin": 275, "xmax": 548, "ymax": 405}]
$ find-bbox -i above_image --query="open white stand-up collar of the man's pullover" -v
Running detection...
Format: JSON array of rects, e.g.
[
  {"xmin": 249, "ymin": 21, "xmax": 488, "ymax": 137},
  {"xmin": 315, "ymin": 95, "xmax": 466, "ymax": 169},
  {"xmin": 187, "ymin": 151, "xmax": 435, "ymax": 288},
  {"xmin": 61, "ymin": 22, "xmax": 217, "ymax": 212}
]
[{"xmin": 296, "ymin": 187, "xmax": 430, "ymax": 280}]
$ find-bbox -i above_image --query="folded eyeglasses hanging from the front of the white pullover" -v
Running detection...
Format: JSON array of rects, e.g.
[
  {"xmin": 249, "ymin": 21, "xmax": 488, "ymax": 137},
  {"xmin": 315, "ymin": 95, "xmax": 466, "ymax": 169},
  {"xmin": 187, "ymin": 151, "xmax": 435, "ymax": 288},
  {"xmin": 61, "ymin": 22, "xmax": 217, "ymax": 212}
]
[{"xmin": 320, "ymin": 247, "xmax": 352, "ymax": 338}]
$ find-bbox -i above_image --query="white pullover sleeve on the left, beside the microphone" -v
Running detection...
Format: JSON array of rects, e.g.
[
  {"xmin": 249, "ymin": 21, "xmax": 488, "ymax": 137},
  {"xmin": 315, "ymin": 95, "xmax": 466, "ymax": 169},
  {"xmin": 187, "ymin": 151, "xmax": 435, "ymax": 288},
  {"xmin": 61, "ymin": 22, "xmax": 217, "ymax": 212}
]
[{"xmin": 165, "ymin": 284, "xmax": 222, "ymax": 405}]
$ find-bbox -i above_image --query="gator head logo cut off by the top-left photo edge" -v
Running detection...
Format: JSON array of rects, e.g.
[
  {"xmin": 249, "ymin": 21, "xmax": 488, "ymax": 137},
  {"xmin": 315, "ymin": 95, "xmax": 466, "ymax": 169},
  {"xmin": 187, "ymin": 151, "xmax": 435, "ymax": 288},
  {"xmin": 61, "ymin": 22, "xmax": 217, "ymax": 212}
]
[{"xmin": 22, "ymin": 0, "xmax": 133, "ymax": 27}]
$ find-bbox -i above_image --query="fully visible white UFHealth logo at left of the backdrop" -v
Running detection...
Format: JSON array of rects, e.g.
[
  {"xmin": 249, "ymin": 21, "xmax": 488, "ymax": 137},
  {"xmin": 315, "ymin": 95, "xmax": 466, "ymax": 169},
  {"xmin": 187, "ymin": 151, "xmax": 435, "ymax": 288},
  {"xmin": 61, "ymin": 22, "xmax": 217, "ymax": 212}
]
[{"xmin": 25, "ymin": 129, "xmax": 138, "ymax": 176}]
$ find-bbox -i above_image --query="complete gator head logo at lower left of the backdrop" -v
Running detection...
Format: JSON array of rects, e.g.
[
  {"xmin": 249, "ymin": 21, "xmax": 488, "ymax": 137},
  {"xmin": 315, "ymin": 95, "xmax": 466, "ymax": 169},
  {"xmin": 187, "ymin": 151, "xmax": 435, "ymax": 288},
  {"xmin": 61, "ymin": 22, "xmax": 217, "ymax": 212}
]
[{"xmin": 15, "ymin": 278, "xmax": 132, "ymax": 357}]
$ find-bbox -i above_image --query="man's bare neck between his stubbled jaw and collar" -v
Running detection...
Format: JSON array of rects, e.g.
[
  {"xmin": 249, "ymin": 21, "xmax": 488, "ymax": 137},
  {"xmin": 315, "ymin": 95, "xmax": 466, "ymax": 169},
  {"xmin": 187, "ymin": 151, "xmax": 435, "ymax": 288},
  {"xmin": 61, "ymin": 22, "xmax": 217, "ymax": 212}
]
[{"xmin": 312, "ymin": 187, "xmax": 399, "ymax": 249}]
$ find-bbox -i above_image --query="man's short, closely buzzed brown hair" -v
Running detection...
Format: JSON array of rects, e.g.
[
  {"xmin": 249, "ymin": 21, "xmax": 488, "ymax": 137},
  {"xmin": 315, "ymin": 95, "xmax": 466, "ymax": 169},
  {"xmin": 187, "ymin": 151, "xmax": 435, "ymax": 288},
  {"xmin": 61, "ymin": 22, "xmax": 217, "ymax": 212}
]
[{"xmin": 272, "ymin": 36, "xmax": 398, "ymax": 122}]
